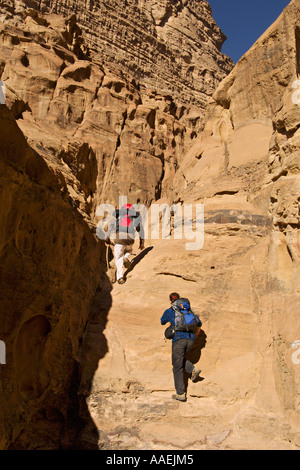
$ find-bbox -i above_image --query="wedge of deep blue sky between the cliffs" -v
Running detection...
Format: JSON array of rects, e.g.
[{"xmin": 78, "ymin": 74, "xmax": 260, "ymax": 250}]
[{"xmin": 208, "ymin": 0, "xmax": 290, "ymax": 62}]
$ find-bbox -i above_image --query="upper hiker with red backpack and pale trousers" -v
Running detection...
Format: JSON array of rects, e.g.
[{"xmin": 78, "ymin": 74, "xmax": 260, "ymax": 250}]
[{"xmin": 105, "ymin": 204, "xmax": 144, "ymax": 284}]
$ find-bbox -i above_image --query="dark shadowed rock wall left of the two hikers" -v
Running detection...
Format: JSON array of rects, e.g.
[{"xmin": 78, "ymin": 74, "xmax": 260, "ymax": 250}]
[{"xmin": 0, "ymin": 105, "xmax": 109, "ymax": 449}]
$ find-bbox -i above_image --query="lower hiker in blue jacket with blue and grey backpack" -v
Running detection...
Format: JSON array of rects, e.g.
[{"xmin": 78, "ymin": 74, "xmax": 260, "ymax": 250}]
[{"xmin": 160, "ymin": 292, "xmax": 202, "ymax": 401}]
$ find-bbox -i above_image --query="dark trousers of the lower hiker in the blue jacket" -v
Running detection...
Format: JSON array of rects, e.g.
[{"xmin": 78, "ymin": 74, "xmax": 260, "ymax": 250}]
[{"xmin": 172, "ymin": 339, "xmax": 194, "ymax": 395}]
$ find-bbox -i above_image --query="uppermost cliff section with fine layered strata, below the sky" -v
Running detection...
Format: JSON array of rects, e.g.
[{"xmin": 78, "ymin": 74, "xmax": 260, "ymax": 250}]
[{"xmin": 9, "ymin": 0, "xmax": 232, "ymax": 108}]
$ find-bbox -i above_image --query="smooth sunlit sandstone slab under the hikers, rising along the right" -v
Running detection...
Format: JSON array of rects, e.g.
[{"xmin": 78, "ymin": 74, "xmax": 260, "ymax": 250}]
[{"xmin": 80, "ymin": 1, "xmax": 300, "ymax": 450}]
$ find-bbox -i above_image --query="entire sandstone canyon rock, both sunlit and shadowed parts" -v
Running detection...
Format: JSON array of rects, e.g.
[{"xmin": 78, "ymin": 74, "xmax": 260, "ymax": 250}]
[{"xmin": 0, "ymin": 0, "xmax": 300, "ymax": 450}]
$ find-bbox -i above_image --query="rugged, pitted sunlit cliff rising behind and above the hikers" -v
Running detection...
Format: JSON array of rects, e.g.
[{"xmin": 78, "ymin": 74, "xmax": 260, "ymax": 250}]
[{"xmin": 1, "ymin": 1, "xmax": 232, "ymax": 216}]
